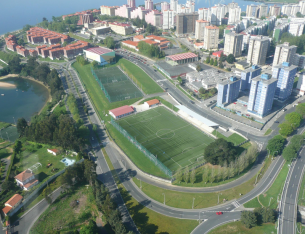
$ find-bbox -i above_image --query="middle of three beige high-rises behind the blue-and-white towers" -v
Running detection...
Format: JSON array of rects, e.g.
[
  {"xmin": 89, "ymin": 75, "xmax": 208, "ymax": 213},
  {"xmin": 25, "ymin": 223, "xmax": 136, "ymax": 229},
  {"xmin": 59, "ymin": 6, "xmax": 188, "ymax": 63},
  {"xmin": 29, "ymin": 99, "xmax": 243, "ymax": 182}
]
[{"xmin": 247, "ymin": 36, "xmax": 269, "ymax": 65}]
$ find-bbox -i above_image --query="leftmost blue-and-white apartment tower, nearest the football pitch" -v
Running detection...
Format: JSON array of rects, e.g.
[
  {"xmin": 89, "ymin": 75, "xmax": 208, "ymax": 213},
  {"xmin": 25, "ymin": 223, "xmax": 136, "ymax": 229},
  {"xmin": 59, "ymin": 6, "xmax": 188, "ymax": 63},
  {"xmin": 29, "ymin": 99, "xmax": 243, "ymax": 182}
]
[{"xmin": 217, "ymin": 76, "xmax": 240, "ymax": 107}]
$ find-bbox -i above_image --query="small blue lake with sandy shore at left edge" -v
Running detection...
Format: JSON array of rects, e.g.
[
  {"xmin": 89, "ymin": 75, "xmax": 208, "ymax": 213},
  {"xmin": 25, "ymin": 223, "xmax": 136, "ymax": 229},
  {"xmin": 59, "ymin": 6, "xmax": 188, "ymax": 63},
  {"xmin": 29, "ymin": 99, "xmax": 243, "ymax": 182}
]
[{"xmin": 0, "ymin": 78, "xmax": 49, "ymax": 124}]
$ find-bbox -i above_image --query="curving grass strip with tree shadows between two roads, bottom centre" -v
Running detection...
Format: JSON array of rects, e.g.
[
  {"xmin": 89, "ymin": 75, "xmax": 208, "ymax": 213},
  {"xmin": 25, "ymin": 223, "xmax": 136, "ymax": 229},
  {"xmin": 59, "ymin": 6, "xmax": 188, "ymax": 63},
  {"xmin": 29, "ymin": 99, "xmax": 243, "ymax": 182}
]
[{"xmin": 103, "ymin": 150, "xmax": 198, "ymax": 234}]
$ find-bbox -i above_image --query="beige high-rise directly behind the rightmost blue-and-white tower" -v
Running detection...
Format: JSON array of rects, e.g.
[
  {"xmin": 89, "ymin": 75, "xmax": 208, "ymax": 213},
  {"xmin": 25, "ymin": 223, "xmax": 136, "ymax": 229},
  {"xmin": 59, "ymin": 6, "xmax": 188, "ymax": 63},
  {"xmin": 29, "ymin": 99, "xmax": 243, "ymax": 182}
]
[{"xmin": 273, "ymin": 42, "xmax": 297, "ymax": 66}]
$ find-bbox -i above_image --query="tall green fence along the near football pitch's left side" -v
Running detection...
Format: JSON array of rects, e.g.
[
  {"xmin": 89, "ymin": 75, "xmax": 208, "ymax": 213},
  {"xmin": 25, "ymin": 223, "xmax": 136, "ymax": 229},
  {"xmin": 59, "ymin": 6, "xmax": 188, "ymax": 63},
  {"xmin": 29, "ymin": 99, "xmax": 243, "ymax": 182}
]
[{"xmin": 111, "ymin": 118, "xmax": 172, "ymax": 177}]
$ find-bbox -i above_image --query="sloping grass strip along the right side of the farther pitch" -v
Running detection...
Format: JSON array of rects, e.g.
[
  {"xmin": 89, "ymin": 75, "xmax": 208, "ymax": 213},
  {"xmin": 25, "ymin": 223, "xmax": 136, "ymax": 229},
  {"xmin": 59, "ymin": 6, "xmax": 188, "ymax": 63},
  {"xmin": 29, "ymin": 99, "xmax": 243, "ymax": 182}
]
[{"xmin": 118, "ymin": 59, "xmax": 163, "ymax": 94}]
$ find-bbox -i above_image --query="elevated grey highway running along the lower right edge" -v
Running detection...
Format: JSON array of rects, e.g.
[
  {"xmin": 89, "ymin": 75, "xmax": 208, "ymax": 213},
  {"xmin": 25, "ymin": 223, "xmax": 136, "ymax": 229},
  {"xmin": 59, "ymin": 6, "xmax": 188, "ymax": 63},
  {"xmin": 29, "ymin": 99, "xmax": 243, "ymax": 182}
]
[{"xmin": 278, "ymin": 144, "xmax": 305, "ymax": 234}]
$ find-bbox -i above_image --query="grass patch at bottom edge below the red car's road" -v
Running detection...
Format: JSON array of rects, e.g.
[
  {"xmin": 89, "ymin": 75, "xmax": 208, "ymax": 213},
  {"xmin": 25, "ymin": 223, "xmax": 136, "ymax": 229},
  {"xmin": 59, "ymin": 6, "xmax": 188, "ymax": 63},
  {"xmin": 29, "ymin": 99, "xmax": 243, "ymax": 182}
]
[{"xmin": 209, "ymin": 221, "xmax": 277, "ymax": 234}]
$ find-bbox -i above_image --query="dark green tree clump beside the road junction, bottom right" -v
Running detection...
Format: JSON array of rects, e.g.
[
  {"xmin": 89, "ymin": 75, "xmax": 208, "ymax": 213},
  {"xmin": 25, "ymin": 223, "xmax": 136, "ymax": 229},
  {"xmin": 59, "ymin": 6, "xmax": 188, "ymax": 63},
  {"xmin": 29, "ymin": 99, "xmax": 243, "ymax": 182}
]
[{"xmin": 240, "ymin": 207, "xmax": 276, "ymax": 228}]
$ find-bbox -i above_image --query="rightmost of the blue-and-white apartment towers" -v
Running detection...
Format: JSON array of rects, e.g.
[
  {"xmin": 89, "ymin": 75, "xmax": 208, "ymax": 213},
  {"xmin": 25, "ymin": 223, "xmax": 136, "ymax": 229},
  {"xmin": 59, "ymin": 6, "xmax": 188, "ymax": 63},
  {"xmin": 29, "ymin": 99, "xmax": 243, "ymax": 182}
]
[{"xmin": 272, "ymin": 62, "xmax": 297, "ymax": 101}]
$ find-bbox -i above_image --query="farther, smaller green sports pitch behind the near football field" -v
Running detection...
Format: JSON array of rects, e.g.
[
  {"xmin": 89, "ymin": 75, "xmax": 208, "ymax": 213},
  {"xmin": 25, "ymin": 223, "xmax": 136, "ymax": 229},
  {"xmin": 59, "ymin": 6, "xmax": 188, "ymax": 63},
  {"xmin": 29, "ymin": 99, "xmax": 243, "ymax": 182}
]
[{"xmin": 92, "ymin": 67, "xmax": 143, "ymax": 102}]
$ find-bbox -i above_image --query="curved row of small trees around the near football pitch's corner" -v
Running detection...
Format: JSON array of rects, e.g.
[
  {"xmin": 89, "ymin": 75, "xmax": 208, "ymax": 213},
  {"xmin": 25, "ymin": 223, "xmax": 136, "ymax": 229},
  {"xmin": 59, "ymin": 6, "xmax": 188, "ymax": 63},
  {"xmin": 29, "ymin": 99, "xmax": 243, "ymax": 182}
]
[{"xmin": 175, "ymin": 143, "xmax": 258, "ymax": 184}]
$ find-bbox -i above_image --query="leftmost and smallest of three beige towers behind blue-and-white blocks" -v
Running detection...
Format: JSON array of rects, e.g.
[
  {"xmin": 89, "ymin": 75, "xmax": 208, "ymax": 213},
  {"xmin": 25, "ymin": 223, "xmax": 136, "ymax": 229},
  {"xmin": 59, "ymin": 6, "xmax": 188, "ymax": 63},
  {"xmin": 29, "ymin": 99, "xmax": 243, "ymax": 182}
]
[{"xmin": 223, "ymin": 32, "xmax": 243, "ymax": 57}]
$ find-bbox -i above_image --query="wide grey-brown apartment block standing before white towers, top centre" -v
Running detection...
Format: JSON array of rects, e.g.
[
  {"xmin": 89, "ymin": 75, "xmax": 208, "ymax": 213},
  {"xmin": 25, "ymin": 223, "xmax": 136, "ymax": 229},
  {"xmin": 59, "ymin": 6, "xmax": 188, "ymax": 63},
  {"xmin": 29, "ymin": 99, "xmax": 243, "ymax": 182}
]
[{"xmin": 176, "ymin": 12, "xmax": 199, "ymax": 35}]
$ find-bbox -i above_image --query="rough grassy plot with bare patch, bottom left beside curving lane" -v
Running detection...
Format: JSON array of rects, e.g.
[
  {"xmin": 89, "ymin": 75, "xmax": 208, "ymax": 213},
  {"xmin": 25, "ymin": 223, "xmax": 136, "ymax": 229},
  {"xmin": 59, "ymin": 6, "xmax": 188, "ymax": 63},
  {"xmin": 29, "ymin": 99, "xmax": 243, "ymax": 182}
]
[{"xmin": 31, "ymin": 186, "xmax": 92, "ymax": 234}]
